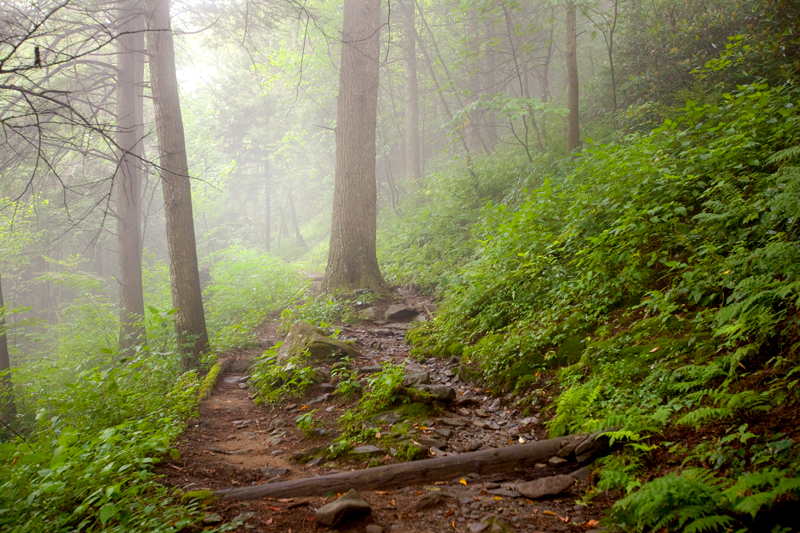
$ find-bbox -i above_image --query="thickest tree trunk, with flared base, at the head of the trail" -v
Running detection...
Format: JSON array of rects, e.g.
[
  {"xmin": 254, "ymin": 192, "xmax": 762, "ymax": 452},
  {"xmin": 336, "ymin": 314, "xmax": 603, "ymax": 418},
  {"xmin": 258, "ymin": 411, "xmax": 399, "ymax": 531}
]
[{"xmin": 322, "ymin": 0, "xmax": 385, "ymax": 291}]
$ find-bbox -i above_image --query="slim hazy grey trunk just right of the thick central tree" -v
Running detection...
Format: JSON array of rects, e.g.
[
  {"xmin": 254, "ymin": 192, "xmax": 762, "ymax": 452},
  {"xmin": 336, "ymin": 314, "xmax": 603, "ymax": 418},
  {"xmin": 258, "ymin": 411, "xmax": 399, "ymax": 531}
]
[{"xmin": 400, "ymin": 0, "xmax": 422, "ymax": 181}]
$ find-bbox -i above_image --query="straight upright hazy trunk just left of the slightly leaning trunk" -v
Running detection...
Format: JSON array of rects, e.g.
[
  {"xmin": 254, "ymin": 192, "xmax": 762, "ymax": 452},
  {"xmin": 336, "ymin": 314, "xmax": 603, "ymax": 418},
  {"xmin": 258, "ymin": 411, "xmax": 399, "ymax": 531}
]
[{"xmin": 115, "ymin": 0, "xmax": 146, "ymax": 354}]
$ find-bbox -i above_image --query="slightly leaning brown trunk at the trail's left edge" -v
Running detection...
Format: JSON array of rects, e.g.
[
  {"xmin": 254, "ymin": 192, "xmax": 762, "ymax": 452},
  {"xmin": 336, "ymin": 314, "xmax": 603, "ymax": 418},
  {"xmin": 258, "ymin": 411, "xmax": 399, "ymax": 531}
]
[{"xmin": 145, "ymin": 0, "xmax": 208, "ymax": 367}]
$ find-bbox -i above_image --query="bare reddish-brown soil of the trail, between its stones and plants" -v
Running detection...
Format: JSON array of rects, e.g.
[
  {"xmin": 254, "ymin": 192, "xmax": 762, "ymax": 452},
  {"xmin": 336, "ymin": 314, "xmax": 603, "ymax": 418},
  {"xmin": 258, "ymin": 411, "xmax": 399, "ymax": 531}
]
[{"xmin": 158, "ymin": 302, "xmax": 611, "ymax": 533}]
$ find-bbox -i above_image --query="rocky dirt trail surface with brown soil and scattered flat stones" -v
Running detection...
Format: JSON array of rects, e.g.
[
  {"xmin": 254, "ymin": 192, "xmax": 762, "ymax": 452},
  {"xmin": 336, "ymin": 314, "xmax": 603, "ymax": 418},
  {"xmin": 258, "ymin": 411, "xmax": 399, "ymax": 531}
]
[{"xmin": 158, "ymin": 296, "xmax": 612, "ymax": 533}]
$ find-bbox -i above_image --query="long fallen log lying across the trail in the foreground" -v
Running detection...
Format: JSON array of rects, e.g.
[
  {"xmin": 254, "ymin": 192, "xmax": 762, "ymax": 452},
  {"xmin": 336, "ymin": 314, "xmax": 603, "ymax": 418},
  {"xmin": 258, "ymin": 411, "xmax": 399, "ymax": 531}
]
[{"xmin": 214, "ymin": 437, "xmax": 570, "ymax": 500}]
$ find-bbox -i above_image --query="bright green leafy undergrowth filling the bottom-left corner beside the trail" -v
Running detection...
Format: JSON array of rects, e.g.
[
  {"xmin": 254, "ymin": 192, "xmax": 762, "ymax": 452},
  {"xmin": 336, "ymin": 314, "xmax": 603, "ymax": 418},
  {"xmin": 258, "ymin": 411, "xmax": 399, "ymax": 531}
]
[{"xmin": 0, "ymin": 354, "xmax": 206, "ymax": 532}]
